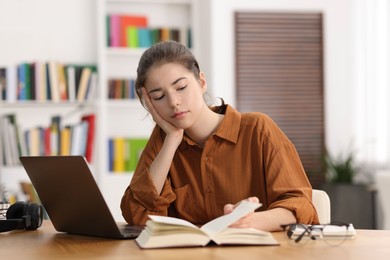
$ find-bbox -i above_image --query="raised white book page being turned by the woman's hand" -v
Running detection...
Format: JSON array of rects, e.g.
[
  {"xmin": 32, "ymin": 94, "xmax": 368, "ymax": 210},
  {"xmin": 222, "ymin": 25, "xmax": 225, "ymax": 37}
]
[{"xmin": 201, "ymin": 200, "xmax": 262, "ymax": 237}]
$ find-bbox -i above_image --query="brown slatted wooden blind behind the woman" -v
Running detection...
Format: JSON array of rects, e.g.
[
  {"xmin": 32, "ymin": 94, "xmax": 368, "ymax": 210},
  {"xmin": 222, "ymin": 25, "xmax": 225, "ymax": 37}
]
[{"xmin": 235, "ymin": 12, "xmax": 324, "ymax": 187}]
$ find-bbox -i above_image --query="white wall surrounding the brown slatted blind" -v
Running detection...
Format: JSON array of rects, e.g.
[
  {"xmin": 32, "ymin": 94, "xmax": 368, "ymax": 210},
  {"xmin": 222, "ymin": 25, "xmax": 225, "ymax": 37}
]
[{"xmin": 206, "ymin": 0, "xmax": 355, "ymax": 157}]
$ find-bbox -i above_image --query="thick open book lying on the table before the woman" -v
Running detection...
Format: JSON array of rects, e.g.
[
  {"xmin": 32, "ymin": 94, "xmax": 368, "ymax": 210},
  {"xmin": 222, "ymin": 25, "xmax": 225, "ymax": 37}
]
[{"xmin": 136, "ymin": 200, "xmax": 279, "ymax": 248}]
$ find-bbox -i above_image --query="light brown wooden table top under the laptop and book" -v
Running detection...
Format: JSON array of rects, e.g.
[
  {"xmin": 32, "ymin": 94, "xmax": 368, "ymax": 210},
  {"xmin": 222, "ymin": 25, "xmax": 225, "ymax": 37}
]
[{"xmin": 0, "ymin": 221, "xmax": 390, "ymax": 260}]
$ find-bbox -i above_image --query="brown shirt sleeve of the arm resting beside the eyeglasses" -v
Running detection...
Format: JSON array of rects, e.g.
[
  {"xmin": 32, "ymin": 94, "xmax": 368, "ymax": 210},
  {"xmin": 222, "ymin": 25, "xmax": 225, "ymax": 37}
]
[{"xmin": 259, "ymin": 117, "xmax": 318, "ymax": 224}]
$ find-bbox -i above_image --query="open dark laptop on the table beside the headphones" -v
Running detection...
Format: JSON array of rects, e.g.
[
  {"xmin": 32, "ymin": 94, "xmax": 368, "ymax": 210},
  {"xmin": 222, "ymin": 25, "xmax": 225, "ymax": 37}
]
[{"xmin": 20, "ymin": 156, "xmax": 143, "ymax": 239}]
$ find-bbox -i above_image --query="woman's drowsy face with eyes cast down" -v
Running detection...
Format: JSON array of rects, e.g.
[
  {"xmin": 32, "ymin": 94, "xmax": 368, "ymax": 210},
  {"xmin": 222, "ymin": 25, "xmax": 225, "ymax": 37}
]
[{"xmin": 145, "ymin": 63, "xmax": 207, "ymax": 129}]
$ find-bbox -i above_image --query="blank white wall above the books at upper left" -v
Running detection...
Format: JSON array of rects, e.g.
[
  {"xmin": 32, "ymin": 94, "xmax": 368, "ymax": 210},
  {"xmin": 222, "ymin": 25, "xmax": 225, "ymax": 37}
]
[{"xmin": 0, "ymin": 0, "xmax": 97, "ymax": 66}]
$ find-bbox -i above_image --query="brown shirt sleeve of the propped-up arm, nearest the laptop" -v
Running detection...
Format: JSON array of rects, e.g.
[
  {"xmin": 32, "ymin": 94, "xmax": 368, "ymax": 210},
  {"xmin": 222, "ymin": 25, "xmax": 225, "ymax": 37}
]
[{"xmin": 121, "ymin": 127, "xmax": 176, "ymax": 225}]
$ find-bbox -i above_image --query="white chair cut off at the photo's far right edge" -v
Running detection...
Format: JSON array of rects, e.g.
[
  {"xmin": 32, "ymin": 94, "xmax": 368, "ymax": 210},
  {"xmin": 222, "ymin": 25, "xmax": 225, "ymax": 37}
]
[{"xmin": 375, "ymin": 170, "xmax": 390, "ymax": 230}]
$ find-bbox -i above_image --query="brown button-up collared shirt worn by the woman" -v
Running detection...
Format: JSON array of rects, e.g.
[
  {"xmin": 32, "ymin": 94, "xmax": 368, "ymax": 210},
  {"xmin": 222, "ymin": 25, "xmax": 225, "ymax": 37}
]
[{"xmin": 121, "ymin": 105, "xmax": 318, "ymax": 225}]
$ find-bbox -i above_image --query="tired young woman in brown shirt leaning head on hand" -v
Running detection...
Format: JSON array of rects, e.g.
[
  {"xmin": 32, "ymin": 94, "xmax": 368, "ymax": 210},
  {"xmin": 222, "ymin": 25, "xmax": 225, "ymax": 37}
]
[{"xmin": 121, "ymin": 41, "xmax": 318, "ymax": 231}]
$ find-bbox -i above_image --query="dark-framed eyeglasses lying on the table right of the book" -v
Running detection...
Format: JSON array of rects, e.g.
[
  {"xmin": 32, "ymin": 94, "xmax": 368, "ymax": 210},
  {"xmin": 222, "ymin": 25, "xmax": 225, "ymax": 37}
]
[{"xmin": 281, "ymin": 222, "xmax": 356, "ymax": 246}]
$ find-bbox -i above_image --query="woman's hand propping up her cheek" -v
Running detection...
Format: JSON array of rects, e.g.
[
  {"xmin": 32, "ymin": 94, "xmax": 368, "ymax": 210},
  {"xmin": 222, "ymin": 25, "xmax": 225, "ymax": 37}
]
[{"xmin": 142, "ymin": 87, "xmax": 184, "ymax": 143}]
